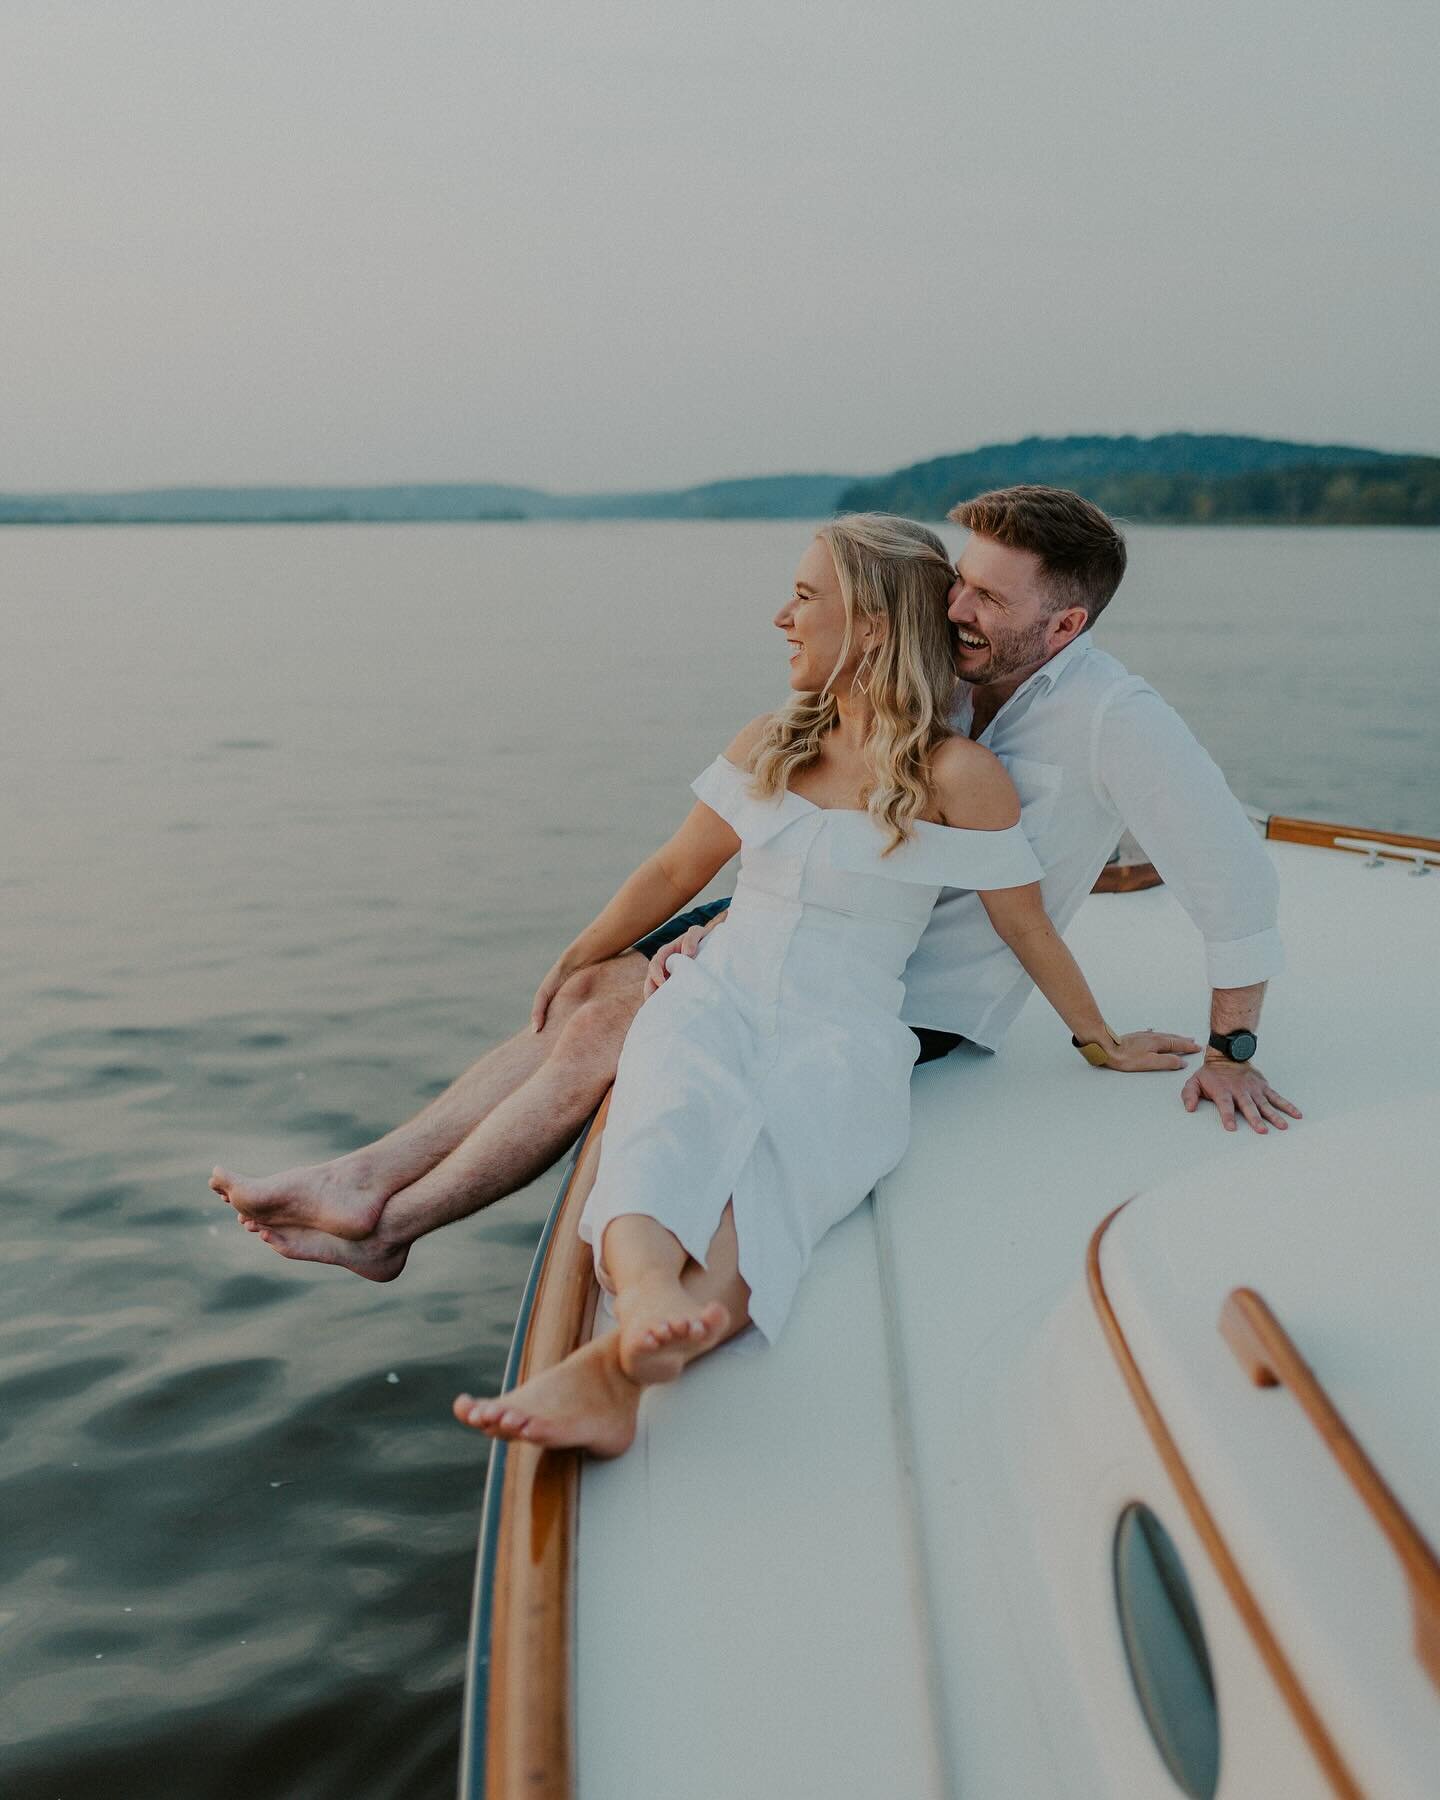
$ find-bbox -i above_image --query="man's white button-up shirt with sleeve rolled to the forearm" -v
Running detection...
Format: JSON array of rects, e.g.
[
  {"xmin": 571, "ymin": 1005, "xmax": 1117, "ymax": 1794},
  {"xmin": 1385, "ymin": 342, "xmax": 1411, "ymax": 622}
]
[{"xmin": 900, "ymin": 635, "xmax": 1285, "ymax": 1049}]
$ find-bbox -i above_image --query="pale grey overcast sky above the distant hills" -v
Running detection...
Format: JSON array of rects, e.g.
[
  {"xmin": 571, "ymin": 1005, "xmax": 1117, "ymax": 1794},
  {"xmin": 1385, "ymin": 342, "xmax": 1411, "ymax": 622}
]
[{"xmin": 0, "ymin": 0, "xmax": 1440, "ymax": 490}]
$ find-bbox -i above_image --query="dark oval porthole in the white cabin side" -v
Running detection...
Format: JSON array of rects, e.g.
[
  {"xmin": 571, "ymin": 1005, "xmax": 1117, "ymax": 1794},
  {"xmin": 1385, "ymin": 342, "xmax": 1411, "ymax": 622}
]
[{"xmin": 1114, "ymin": 1503, "xmax": 1220, "ymax": 1800}]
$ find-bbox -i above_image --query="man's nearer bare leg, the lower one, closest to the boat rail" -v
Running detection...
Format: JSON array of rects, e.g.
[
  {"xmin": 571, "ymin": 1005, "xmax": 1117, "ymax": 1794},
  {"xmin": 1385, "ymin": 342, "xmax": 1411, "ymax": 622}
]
[{"xmin": 232, "ymin": 954, "xmax": 646, "ymax": 1282}]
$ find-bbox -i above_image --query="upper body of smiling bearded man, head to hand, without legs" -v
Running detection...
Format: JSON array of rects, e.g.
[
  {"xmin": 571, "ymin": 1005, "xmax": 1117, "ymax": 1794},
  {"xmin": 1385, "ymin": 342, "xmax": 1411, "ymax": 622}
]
[{"xmin": 904, "ymin": 486, "xmax": 1300, "ymax": 1132}]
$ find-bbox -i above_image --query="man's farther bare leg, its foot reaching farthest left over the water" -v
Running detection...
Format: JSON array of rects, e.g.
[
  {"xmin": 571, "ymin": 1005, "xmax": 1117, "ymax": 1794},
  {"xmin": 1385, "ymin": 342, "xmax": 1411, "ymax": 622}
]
[{"xmin": 211, "ymin": 952, "xmax": 644, "ymax": 1240}]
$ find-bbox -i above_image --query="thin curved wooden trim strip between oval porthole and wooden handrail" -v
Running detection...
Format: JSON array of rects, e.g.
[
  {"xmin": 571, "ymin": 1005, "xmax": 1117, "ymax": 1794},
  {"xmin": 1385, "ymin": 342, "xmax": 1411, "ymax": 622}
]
[{"xmin": 1085, "ymin": 1201, "xmax": 1364, "ymax": 1800}]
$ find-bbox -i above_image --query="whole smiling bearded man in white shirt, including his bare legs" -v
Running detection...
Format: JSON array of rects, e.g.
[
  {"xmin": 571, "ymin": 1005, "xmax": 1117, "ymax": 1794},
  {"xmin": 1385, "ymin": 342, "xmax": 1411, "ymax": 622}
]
[{"xmin": 211, "ymin": 486, "xmax": 1300, "ymax": 1282}]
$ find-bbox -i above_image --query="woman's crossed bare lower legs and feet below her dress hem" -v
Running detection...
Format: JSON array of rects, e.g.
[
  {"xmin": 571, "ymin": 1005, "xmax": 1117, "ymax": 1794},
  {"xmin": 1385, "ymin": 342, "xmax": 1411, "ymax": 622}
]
[{"xmin": 454, "ymin": 1206, "xmax": 751, "ymax": 1456}]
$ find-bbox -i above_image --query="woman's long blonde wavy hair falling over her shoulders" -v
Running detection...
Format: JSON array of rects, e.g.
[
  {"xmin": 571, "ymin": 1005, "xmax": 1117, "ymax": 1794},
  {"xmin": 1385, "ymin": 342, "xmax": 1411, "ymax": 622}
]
[{"xmin": 749, "ymin": 513, "xmax": 956, "ymax": 855}]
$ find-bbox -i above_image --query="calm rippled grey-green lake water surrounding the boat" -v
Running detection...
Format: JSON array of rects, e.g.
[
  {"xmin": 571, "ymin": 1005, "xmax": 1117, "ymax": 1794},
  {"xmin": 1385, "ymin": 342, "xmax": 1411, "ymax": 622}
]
[{"xmin": 0, "ymin": 524, "xmax": 1440, "ymax": 1800}]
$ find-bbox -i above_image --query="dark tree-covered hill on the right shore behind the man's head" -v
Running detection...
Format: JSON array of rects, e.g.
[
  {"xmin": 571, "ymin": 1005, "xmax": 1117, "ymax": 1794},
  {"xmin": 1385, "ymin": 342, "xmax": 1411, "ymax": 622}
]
[{"xmin": 839, "ymin": 432, "xmax": 1440, "ymax": 524}]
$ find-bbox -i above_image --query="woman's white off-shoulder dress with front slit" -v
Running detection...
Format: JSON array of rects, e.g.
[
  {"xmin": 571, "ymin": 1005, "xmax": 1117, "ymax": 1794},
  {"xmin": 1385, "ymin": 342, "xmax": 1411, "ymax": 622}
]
[{"xmin": 580, "ymin": 756, "xmax": 1040, "ymax": 1343}]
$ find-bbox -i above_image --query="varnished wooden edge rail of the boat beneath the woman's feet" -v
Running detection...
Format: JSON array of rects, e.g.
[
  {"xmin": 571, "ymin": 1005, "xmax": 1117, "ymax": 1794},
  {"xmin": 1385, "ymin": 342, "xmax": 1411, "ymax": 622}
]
[{"xmin": 459, "ymin": 1094, "xmax": 610, "ymax": 1800}]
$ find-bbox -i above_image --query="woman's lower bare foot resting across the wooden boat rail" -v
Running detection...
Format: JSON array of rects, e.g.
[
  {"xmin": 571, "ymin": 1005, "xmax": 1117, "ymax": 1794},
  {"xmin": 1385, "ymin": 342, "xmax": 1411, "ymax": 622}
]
[{"xmin": 454, "ymin": 1332, "xmax": 641, "ymax": 1456}]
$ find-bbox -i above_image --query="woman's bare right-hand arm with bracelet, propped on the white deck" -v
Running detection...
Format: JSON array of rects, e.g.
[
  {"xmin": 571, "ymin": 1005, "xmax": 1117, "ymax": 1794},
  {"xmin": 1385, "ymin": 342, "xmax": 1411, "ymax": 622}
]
[{"xmin": 932, "ymin": 738, "xmax": 1201, "ymax": 1073}]
